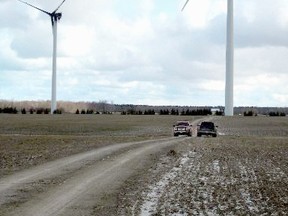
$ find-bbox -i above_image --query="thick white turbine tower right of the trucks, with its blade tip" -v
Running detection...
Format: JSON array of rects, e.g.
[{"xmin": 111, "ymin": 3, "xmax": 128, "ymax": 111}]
[{"xmin": 182, "ymin": 0, "xmax": 234, "ymax": 116}]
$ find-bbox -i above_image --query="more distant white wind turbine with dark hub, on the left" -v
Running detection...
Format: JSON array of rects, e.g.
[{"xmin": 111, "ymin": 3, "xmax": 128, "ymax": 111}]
[{"xmin": 18, "ymin": 0, "xmax": 66, "ymax": 114}]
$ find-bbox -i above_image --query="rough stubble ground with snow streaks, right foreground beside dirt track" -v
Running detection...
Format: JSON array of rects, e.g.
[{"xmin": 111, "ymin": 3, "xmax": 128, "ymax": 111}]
[{"xmin": 146, "ymin": 137, "xmax": 288, "ymax": 215}]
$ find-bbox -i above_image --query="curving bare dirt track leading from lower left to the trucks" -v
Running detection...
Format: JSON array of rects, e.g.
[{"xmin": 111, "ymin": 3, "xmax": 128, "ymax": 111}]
[{"xmin": 0, "ymin": 137, "xmax": 189, "ymax": 216}]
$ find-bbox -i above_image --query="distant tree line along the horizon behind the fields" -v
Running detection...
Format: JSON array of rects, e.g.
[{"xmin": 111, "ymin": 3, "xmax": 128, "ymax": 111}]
[{"xmin": 0, "ymin": 100, "xmax": 288, "ymax": 116}]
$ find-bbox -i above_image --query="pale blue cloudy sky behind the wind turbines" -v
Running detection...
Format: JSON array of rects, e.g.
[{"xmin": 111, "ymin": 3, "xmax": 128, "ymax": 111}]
[{"xmin": 0, "ymin": 0, "xmax": 288, "ymax": 107}]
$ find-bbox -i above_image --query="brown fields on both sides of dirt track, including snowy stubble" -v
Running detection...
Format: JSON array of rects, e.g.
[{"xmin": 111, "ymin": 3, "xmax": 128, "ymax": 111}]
[{"xmin": 0, "ymin": 114, "xmax": 288, "ymax": 215}]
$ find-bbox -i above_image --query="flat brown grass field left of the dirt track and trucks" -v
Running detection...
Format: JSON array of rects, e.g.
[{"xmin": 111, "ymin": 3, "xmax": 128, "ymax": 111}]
[{"xmin": 0, "ymin": 114, "xmax": 200, "ymax": 176}]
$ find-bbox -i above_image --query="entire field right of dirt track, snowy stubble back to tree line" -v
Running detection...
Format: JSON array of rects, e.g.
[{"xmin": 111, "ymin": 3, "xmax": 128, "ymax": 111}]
[{"xmin": 119, "ymin": 117, "xmax": 288, "ymax": 215}]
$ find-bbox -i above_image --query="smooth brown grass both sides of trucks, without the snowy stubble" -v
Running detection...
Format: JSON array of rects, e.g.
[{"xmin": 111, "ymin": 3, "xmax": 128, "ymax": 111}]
[{"xmin": 0, "ymin": 114, "xmax": 288, "ymax": 177}]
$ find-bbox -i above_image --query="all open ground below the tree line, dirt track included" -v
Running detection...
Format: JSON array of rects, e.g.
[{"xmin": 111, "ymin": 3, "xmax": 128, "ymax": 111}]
[{"xmin": 0, "ymin": 115, "xmax": 288, "ymax": 216}]
